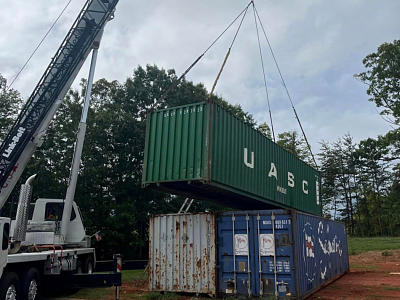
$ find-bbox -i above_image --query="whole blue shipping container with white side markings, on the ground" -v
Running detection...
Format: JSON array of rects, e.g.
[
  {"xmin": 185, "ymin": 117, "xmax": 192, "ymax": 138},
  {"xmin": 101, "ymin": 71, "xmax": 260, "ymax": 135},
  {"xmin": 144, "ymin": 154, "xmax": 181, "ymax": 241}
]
[{"xmin": 217, "ymin": 210, "xmax": 349, "ymax": 299}]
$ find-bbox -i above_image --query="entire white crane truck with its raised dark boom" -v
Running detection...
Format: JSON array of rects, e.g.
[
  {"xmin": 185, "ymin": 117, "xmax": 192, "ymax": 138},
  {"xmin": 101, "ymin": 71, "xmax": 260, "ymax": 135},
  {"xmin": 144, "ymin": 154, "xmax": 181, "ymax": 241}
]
[{"xmin": 0, "ymin": 0, "xmax": 121, "ymax": 300}]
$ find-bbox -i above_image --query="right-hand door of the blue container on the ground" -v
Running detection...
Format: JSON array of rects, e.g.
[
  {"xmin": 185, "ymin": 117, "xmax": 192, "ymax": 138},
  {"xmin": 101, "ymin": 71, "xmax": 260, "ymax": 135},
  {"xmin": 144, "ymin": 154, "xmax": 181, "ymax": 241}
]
[{"xmin": 253, "ymin": 213, "xmax": 296, "ymax": 297}]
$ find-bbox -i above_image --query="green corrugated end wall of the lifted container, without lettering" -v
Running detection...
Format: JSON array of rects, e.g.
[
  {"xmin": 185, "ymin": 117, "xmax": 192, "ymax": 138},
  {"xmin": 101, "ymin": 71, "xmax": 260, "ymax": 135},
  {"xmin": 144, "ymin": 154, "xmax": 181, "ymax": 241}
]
[{"xmin": 143, "ymin": 103, "xmax": 208, "ymax": 184}]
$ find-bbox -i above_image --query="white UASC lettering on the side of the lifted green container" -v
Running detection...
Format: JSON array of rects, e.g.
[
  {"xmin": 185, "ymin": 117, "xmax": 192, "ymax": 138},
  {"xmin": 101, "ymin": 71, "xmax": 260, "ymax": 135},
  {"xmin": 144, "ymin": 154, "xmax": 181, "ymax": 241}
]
[{"xmin": 243, "ymin": 147, "xmax": 319, "ymax": 197}]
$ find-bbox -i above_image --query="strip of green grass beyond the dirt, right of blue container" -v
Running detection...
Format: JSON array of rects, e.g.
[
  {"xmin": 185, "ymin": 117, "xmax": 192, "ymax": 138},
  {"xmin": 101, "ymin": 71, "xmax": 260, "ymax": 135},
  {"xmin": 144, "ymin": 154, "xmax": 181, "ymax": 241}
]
[{"xmin": 348, "ymin": 237, "xmax": 400, "ymax": 255}]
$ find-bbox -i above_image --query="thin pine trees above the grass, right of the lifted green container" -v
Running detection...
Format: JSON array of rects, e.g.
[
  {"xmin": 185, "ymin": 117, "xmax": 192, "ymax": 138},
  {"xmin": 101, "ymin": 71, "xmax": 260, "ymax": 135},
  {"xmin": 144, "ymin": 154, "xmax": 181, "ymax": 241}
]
[{"xmin": 319, "ymin": 135, "xmax": 400, "ymax": 236}]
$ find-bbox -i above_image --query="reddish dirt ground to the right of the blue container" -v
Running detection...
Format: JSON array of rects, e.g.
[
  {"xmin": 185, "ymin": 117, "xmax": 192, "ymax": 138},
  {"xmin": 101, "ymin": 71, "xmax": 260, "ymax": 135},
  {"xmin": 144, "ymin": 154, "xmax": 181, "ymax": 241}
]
[{"xmin": 310, "ymin": 250, "xmax": 400, "ymax": 300}]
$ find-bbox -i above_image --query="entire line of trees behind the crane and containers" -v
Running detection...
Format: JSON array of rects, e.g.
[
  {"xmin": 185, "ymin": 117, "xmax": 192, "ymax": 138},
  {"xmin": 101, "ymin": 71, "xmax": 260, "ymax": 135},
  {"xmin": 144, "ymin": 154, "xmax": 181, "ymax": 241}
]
[{"xmin": 0, "ymin": 41, "xmax": 400, "ymax": 258}]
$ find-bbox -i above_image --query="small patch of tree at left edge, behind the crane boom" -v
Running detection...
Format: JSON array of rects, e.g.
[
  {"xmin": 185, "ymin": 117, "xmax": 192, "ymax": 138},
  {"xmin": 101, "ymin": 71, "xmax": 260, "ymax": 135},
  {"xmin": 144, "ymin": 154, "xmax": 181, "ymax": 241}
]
[{"xmin": 0, "ymin": 74, "xmax": 22, "ymax": 143}]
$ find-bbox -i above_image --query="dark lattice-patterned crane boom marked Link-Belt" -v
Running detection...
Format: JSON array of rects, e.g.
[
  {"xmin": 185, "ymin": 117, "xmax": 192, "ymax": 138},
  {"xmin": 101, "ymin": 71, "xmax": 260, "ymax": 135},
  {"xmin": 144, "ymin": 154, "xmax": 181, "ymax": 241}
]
[{"xmin": 0, "ymin": 0, "xmax": 118, "ymax": 208}]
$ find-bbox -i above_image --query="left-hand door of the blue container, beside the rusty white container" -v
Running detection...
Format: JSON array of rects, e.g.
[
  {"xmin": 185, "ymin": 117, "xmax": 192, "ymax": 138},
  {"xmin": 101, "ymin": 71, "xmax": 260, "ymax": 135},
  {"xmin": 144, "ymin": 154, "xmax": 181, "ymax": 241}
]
[{"xmin": 218, "ymin": 214, "xmax": 256, "ymax": 296}]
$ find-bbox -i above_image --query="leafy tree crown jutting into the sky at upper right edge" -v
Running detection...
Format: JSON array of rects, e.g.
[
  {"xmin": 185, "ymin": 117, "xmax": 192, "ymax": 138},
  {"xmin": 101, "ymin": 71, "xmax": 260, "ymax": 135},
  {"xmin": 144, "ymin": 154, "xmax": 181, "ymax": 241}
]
[{"xmin": 355, "ymin": 40, "xmax": 400, "ymax": 125}]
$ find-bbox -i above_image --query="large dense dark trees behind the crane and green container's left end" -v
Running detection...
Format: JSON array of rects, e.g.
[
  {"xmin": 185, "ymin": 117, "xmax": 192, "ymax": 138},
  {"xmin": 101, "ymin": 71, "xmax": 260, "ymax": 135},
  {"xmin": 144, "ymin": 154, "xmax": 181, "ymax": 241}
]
[{"xmin": 10, "ymin": 66, "xmax": 253, "ymax": 258}]
